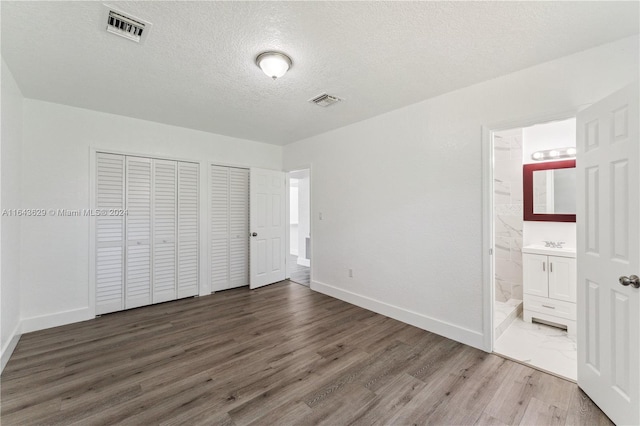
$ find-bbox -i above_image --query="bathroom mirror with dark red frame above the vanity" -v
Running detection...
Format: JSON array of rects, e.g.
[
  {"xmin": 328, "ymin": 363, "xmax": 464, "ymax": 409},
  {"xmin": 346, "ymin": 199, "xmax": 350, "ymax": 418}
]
[{"xmin": 523, "ymin": 160, "xmax": 576, "ymax": 222}]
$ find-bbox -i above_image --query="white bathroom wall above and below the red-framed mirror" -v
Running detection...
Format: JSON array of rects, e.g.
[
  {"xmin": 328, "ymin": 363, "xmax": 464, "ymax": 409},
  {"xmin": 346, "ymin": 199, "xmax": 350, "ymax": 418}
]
[{"xmin": 522, "ymin": 118, "xmax": 576, "ymax": 248}]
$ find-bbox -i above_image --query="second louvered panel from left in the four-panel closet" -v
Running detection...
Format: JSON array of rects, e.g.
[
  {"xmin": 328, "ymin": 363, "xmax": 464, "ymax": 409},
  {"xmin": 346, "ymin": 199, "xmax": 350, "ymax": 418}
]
[{"xmin": 124, "ymin": 157, "xmax": 152, "ymax": 309}]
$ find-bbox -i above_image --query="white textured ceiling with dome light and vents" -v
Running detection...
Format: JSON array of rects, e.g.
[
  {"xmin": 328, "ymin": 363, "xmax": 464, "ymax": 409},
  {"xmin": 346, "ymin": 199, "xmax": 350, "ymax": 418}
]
[{"xmin": 1, "ymin": 1, "xmax": 639, "ymax": 145}]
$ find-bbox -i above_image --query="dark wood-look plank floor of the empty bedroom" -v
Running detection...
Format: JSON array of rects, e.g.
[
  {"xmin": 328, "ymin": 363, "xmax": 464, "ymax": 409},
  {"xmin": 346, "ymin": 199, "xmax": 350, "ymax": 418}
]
[{"xmin": 1, "ymin": 282, "xmax": 610, "ymax": 426}]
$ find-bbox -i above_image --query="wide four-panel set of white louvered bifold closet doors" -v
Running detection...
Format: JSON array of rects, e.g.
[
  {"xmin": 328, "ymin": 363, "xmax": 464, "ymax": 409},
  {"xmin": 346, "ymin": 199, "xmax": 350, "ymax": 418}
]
[{"xmin": 94, "ymin": 153, "xmax": 199, "ymax": 315}]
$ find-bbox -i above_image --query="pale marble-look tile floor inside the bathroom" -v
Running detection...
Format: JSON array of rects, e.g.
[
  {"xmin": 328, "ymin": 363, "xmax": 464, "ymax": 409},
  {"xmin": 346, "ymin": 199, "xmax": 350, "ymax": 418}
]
[{"xmin": 493, "ymin": 317, "xmax": 578, "ymax": 381}]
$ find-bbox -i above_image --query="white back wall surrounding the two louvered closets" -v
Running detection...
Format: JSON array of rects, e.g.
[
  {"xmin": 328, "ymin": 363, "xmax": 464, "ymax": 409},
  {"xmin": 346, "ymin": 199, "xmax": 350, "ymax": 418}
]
[{"xmin": 20, "ymin": 99, "xmax": 282, "ymax": 332}]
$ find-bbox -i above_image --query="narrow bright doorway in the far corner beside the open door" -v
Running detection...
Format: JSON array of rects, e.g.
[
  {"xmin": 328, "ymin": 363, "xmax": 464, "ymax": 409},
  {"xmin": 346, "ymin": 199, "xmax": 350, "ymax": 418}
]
[{"xmin": 287, "ymin": 169, "xmax": 311, "ymax": 286}]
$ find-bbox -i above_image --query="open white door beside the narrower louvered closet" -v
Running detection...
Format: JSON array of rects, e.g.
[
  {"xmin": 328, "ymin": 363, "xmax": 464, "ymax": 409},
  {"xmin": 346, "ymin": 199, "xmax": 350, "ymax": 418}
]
[{"xmin": 249, "ymin": 169, "xmax": 287, "ymax": 288}]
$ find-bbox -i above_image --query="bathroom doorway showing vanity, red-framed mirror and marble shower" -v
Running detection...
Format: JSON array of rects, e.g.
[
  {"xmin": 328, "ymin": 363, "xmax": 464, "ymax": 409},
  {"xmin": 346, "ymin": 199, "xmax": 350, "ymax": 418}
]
[{"xmin": 491, "ymin": 118, "xmax": 577, "ymax": 381}]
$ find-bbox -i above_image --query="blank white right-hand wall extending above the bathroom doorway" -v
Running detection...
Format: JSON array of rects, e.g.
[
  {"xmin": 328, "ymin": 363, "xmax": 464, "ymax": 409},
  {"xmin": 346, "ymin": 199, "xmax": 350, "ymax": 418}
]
[{"xmin": 284, "ymin": 37, "xmax": 639, "ymax": 349}]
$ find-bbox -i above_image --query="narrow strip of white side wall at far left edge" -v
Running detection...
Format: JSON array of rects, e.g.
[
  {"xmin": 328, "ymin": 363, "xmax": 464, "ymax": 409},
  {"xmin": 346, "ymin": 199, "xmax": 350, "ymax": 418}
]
[{"xmin": 0, "ymin": 59, "xmax": 23, "ymax": 371}]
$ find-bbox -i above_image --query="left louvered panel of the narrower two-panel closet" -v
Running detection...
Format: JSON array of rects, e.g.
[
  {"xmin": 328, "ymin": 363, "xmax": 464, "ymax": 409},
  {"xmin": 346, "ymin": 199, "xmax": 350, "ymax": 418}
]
[{"xmin": 211, "ymin": 166, "xmax": 229, "ymax": 291}]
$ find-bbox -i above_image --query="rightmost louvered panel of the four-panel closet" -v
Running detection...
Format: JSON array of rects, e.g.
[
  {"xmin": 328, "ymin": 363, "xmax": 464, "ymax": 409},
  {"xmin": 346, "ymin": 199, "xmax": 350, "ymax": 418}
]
[{"xmin": 178, "ymin": 162, "xmax": 199, "ymax": 298}]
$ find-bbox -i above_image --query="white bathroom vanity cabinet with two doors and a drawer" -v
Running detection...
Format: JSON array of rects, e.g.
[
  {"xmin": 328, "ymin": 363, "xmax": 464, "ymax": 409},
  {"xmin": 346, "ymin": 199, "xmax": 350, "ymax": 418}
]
[{"xmin": 522, "ymin": 246, "xmax": 576, "ymax": 334}]
